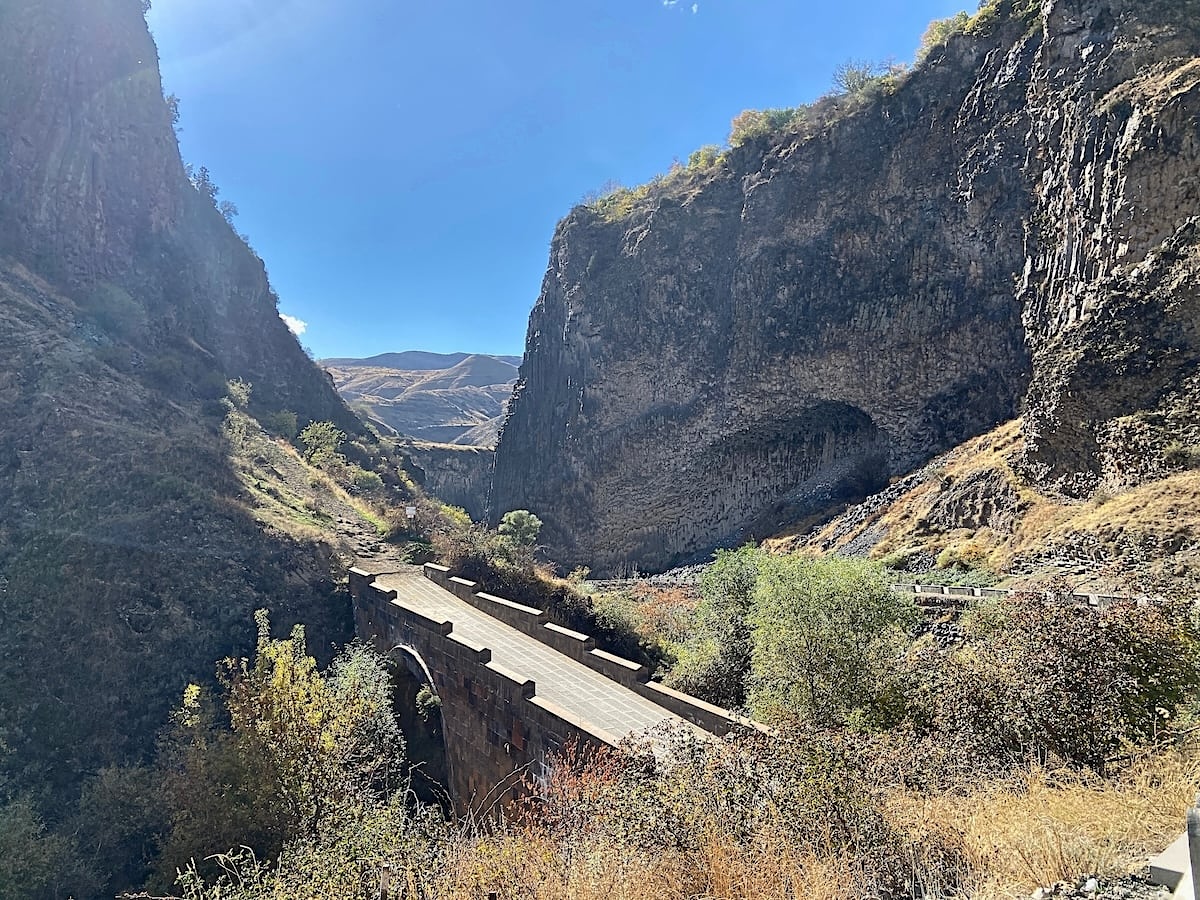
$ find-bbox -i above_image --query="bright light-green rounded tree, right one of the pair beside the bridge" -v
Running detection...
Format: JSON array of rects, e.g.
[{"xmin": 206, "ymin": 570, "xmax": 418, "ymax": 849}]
[{"xmin": 749, "ymin": 556, "xmax": 916, "ymax": 725}]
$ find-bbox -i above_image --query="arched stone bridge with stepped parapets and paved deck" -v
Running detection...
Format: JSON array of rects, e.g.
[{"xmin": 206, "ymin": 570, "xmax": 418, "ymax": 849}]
[{"xmin": 350, "ymin": 564, "xmax": 752, "ymax": 812}]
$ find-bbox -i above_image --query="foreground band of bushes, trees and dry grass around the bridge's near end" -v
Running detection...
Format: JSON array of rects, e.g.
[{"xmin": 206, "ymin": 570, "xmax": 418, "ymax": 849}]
[{"xmin": 49, "ymin": 548, "xmax": 1200, "ymax": 900}]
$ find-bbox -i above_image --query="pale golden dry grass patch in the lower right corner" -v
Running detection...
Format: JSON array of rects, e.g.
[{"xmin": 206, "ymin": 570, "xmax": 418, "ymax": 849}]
[{"xmin": 888, "ymin": 754, "xmax": 1200, "ymax": 900}]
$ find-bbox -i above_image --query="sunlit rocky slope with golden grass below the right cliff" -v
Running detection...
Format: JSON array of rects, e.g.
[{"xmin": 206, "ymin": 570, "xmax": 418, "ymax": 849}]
[{"xmin": 767, "ymin": 420, "xmax": 1200, "ymax": 593}]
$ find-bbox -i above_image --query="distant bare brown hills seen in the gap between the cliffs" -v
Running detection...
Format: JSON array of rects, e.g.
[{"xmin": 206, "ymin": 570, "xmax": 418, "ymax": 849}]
[{"xmin": 320, "ymin": 350, "xmax": 521, "ymax": 446}]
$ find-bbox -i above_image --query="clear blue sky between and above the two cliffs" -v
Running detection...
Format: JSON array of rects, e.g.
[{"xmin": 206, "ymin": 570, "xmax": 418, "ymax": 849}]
[{"xmin": 149, "ymin": 0, "xmax": 973, "ymax": 356}]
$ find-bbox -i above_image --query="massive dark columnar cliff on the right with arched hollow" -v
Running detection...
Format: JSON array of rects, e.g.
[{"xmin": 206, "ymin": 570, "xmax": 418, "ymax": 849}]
[{"xmin": 491, "ymin": 0, "xmax": 1200, "ymax": 571}]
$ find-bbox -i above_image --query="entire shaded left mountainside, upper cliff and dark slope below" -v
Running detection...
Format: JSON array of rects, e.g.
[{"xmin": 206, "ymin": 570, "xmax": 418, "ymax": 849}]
[{"xmin": 0, "ymin": 0, "xmax": 360, "ymax": 896}]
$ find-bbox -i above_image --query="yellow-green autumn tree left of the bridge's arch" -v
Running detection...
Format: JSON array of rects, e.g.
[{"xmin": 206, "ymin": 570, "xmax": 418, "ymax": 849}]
[{"xmin": 154, "ymin": 611, "xmax": 403, "ymax": 876}]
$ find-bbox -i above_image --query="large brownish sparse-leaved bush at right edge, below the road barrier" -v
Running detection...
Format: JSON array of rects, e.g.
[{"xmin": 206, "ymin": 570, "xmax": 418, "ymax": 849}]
[{"xmin": 917, "ymin": 586, "xmax": 1200, "ymax": 774}]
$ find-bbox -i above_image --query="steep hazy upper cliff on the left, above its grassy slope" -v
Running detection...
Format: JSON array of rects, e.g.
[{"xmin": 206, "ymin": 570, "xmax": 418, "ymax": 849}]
[{"xmin": 0, "ymin": 0, "xmax": 359, "ymax": 430}]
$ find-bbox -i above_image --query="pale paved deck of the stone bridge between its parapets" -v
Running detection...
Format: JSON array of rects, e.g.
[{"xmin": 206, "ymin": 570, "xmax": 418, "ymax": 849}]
[{"xmin": 376, "ymin": 571, "xmax": 703, "ymax": 739}]
